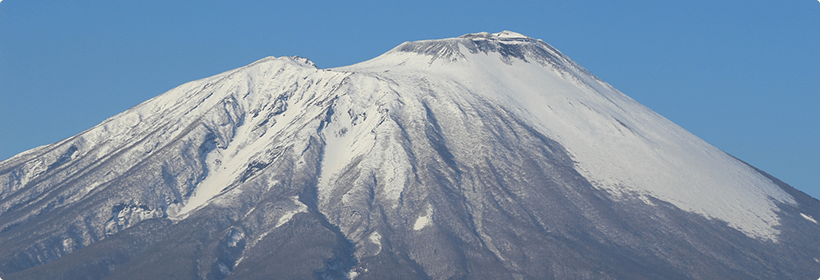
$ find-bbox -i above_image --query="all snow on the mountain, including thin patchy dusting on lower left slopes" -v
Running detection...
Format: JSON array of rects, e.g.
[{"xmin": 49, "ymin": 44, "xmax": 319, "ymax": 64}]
[{"xmin": 0, "ymin": 31, "xmax": 820, "ymax": 279}]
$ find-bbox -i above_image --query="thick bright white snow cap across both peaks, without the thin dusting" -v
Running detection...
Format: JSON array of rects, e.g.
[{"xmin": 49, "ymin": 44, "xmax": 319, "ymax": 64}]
[{"xmin": 72, "ymin": 31, "xmax": 795, "ymax": 241}]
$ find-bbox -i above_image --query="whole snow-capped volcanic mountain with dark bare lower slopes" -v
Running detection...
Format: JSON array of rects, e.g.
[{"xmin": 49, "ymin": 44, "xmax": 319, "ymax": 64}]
[{"xmin": 0, "ymin": 31, "xmax": 820, "ymax": 280}]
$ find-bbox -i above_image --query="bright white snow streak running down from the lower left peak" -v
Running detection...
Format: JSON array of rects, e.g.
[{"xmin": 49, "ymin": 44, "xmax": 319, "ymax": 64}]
[{"xmin": 165, "ymin": 57, "xmax": 343, "ymax": 220}]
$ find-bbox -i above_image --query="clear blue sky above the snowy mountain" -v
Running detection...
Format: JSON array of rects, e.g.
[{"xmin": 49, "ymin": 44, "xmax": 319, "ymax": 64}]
[{"xmin": 0, "ymin": 0, "xmax": 820, "ymax": 197}]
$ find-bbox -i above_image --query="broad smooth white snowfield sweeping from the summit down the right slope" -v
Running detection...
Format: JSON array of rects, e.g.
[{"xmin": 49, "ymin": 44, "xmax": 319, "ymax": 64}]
[{"xmin": 331, "ymin": 32, "xmax": 795, "ymax": 241}]
